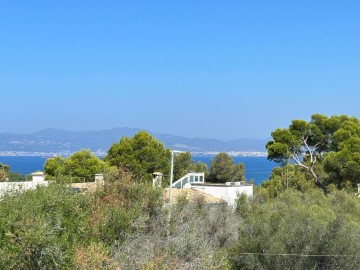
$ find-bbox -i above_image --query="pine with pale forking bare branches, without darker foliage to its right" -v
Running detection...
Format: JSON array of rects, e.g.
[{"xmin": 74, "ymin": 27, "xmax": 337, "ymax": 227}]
[{"xmin": 266, "ymin": 114, "xmax": 359, "ymax": 193}]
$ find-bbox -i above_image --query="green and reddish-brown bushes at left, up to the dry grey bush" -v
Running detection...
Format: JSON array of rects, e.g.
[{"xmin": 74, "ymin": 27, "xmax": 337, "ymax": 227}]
[{"xmin": 0, "ymin": 170, "xmax": 161, "ymax": 269}]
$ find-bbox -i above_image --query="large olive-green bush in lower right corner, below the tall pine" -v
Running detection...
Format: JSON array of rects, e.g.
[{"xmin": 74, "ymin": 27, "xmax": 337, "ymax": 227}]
[{"xmin": 231, "ymin": 189, "xmax": 360, "ymax": 270}]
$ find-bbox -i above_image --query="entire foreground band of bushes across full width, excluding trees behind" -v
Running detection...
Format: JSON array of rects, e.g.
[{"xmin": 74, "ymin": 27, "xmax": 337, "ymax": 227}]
[{"xmin": 0, "ymin": 163, "xmax": 360, "ymax": 269}]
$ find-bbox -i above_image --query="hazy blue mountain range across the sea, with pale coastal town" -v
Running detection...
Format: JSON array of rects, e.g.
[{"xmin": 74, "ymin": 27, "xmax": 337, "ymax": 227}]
[{"xmin": 0, "ymin": 127, "xmax": 266, "ymax": 155}]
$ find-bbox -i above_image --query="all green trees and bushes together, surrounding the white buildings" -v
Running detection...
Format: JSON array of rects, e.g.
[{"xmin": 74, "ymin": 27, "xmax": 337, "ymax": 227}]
[{"xmin": 0, "ymin": 115, "xmax": 360, "ymax": 270}]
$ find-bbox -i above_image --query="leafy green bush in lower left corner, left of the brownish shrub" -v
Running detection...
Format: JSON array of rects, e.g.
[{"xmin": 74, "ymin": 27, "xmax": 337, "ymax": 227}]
[{"xmin": 0, "ymin": 184, "xmax": 91, "ymax": 269}]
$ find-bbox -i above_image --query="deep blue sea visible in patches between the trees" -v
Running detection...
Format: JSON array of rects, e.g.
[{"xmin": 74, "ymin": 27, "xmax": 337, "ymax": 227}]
[{"xmin": 0, "ymin": 156, "xmax": 276, "ymax": 185}]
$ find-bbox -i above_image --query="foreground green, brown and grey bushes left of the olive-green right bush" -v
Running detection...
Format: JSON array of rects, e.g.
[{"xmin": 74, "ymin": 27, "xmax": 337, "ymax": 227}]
[{"xmin": 0, "ymin": 172, "xmax": 237, "ymax": 269}]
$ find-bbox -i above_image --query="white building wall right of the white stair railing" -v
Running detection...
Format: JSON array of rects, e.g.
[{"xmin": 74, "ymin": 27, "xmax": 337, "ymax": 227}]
[{"xmin": 191, "ymin": 185, "xmax": 253, "ymax": 206}]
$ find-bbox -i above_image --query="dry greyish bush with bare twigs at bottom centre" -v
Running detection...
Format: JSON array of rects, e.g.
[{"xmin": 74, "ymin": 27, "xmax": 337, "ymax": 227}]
[{"xmin": 115, "ymin": 199, "xmax": 238, "ymax": 270}]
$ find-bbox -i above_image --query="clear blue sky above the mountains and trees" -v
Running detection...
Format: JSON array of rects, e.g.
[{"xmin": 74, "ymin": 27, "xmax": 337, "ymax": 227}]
[{"xmin": 0, "ymin": 0, "xmax": 360, "ymax": 140}]
